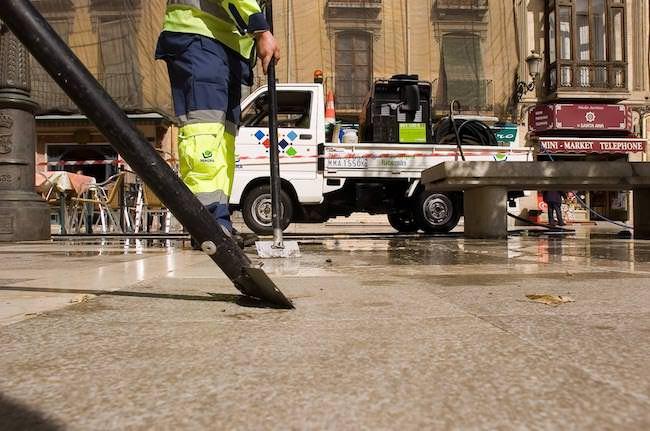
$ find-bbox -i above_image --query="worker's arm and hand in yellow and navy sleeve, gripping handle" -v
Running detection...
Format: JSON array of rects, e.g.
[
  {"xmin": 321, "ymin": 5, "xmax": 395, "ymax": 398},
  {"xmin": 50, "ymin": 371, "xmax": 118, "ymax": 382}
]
[{"xmin": 221, "ymin": 0, "xmax": 280, "ymax": 73}]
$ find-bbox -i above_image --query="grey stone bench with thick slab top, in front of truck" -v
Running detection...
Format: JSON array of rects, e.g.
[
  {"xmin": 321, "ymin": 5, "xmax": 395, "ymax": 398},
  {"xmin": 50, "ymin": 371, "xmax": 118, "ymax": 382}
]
[{"xmin": 421, "ymin": 162, "xmax": 650, "ymax": 239}]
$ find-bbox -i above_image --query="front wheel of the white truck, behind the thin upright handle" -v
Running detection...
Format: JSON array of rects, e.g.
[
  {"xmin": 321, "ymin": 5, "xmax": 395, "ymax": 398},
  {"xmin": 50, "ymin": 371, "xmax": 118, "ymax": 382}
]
[{"xmin": 241, "ymin": 185, "xmax": 293, "ymax": 235}]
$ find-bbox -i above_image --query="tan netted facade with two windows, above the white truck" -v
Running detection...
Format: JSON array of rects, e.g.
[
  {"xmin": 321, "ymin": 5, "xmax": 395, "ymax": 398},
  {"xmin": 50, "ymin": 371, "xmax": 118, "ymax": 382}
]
[{"xmin": 264, "ymin": 0, "xmax": 519, "ymax": 118}]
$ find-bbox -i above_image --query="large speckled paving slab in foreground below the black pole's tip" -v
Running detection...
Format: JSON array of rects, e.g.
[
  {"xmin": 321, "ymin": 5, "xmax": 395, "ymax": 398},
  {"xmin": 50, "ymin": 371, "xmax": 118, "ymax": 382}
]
[{"xmin": 0, "ymin": 278, "xmax": 650, "ymax": 429}]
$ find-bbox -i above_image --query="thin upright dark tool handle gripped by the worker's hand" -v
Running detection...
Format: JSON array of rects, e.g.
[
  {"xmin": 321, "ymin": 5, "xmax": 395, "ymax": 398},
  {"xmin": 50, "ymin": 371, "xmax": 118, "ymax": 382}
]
[{"xmin": 266, "ymin": 0, "xmax": 284, "ymax": 248}]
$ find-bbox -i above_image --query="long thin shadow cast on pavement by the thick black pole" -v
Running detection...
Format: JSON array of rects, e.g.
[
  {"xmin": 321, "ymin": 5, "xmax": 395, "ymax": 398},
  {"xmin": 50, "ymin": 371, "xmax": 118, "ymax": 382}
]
[{"xmin": 0, "ymin": 286, "xmax": 278, "ymax": 309}]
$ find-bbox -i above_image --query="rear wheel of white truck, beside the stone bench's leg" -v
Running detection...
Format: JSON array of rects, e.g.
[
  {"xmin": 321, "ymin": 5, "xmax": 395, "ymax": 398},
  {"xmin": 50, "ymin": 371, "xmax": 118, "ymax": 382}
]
[{"xmin": 413, "ymin": 190, "xmax": 460, "ymax": 233}]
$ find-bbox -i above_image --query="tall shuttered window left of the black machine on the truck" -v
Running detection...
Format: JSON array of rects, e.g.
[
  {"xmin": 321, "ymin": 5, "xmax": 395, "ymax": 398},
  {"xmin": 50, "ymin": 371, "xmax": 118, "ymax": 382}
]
[{"xmin": 335, "ymin": 31, "xmax": 372, "ymax": 111}]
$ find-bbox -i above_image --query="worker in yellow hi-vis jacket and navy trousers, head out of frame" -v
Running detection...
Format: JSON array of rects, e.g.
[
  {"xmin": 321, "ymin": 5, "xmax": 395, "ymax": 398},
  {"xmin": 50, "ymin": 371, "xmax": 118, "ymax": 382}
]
[{"xmin": 155, "ymin": 0, "xmax": 280, "ymax": 245}]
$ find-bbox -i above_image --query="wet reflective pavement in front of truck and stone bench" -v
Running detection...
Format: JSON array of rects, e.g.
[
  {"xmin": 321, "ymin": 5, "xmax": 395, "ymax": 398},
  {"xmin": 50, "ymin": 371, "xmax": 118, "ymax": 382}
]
[{"xmin": 301, "ymin": 236, "xmax": 650, "ymax": 270}]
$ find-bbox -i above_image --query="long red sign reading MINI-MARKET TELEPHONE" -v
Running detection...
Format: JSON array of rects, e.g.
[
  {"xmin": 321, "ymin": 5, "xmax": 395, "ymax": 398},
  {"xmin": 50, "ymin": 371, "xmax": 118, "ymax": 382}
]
[{"xmin": 539, "ymin": 138, "xmax": 647, "ymax": 154}]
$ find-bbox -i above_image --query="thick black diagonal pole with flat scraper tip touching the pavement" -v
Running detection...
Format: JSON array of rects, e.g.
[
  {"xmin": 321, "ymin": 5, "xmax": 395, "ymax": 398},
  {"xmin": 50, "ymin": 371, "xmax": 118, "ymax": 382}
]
[{"xmin": 0, "ymin": 0, "xmax": 293, "ymax": 308}]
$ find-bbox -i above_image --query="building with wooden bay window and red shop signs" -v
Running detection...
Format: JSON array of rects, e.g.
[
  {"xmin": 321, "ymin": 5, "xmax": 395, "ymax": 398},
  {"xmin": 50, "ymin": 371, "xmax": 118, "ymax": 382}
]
[{"xmin": 515, "ymin": 0, "xmax": 650, "ymax": 221}]
